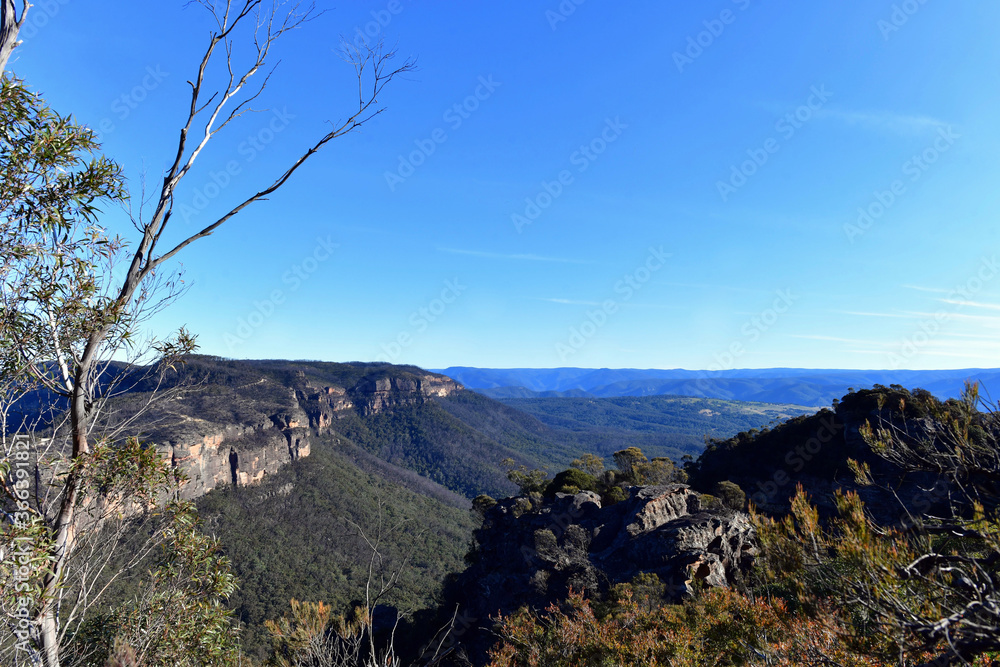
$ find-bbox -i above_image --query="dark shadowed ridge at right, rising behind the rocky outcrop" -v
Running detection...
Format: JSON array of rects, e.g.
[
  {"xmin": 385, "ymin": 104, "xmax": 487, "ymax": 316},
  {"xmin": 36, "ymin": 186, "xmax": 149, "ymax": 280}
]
[{"xmin": 689, "ymin": 386, "xmax": 954, "ymax": 525}]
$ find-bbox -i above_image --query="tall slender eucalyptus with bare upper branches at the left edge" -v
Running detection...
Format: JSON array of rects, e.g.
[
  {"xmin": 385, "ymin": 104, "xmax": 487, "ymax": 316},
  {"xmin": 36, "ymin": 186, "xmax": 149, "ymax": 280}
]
[{"xmin": 0, "ymin": 0, "xmax": 413, "ymax": 667}]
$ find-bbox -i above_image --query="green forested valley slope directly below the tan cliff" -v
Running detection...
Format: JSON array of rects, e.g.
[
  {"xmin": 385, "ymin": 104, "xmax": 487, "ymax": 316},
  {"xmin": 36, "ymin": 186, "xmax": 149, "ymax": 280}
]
[{"xmin": 198, "ymin": 443, "xmax": 473, "ymax": 658}]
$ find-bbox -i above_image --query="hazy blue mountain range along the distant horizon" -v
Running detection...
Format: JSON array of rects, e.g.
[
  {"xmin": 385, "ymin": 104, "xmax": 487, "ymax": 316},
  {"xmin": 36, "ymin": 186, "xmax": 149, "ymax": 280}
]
[{"xmin": 433, "ymin": 366, "xmax": 1000, "ymax": 407}]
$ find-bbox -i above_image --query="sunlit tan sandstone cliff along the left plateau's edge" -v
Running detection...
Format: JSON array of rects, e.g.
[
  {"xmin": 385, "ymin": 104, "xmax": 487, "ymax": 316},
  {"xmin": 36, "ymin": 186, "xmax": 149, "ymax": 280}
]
[{"xmin": 157, "ymin": 371, "xmax": 462, "ymax": 499}]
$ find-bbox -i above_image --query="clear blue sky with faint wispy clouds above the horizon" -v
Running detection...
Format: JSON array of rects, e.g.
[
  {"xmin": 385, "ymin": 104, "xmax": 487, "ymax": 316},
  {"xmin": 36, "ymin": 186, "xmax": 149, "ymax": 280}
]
[{"xmin": 10, "ymin": 0, "xmax": 1000, "ymax": 369}]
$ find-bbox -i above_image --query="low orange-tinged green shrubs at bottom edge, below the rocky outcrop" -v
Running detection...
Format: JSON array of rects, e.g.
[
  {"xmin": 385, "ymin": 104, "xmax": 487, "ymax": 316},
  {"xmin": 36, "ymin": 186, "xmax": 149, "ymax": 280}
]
[{"xmin": 489, "ymin": 584, "xmax": 900, "ymax": 667}]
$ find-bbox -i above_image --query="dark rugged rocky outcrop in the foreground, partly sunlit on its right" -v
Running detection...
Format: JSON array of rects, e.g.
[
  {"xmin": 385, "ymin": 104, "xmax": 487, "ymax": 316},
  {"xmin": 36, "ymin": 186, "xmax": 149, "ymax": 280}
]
[{"xmin": 448, "ymin": 484, "xmax": 757, "ymax": 653}]
